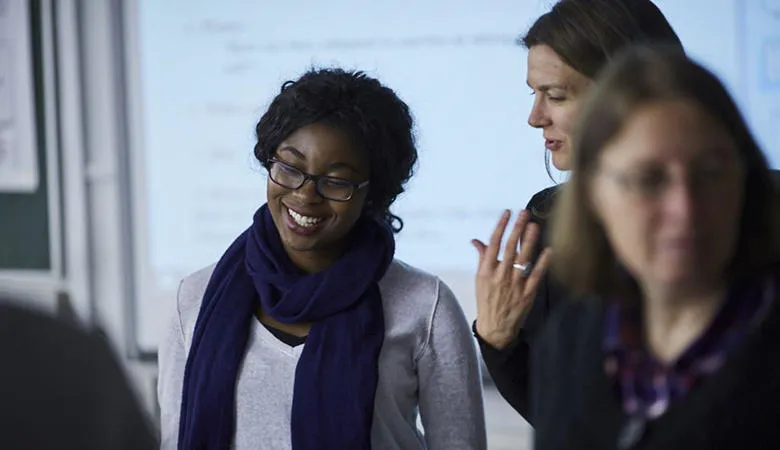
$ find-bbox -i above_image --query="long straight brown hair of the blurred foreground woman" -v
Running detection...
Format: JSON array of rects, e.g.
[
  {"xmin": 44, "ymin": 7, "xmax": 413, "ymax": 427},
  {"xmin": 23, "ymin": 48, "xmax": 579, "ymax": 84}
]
[{"xmin": 552, "ymin": 46, "xmax": 780, "ymax": 293}]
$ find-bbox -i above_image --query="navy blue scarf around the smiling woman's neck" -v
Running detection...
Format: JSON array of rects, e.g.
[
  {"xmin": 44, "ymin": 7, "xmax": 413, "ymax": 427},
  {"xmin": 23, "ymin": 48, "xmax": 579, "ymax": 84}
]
[{"xmin": 179, "ymin": 205, "xmax": 395, "ymax": 450}]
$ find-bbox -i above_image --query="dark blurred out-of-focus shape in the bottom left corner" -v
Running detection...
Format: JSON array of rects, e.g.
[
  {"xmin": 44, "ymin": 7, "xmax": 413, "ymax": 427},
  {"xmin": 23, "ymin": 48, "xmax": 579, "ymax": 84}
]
[{"xmin": 0, "ymin": 303, "xmax": 159, "ymax": 450}]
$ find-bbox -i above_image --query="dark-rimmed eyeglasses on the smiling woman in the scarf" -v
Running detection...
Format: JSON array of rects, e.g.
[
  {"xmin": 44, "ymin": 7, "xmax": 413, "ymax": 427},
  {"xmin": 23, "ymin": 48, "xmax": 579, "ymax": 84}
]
[{"xmin": 268, "ymin": 159, "xmax": 368, "ymax": 202}]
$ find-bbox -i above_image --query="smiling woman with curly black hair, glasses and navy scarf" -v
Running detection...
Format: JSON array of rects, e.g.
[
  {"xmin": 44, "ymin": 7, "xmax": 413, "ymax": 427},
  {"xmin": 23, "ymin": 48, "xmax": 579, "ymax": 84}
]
[{"xmin": 158, "ymin": 69, "xmax": 486, "ymax": 450}]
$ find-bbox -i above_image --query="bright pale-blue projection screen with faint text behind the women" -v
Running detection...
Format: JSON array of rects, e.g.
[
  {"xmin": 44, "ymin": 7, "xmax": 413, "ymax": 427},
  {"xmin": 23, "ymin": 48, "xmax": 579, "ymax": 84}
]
[{"xmin": 126, "ymin": 0, "xmax": 780, "ymax": 352}]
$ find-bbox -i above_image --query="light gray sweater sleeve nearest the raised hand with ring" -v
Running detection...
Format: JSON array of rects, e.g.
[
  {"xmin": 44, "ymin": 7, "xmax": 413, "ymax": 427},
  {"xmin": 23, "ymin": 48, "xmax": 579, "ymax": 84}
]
[{"xmin": 417, "ymin": 281, "xmax": 487, "ymax": 450}]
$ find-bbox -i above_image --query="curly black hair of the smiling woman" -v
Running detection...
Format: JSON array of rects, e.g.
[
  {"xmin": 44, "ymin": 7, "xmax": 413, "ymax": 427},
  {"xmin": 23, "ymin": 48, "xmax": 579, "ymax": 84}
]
[{"xmin": 255, "ymin": 68, "xmax": 417, "ymax": 233}]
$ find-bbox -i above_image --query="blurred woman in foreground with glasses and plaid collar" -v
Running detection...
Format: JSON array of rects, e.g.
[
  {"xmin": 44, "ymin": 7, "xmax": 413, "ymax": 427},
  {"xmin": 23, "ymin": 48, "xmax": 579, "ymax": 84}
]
[{"xmin": 531, "ymin": 44, "xmax": 780, "ymax": 450}]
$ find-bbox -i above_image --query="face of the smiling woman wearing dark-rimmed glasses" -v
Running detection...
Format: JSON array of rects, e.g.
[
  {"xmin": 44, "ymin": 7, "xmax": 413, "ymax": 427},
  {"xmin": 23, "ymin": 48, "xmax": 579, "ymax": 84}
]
[{"xmin": 264, "ymin": 123, "xmax": 369, "ymax": 272}]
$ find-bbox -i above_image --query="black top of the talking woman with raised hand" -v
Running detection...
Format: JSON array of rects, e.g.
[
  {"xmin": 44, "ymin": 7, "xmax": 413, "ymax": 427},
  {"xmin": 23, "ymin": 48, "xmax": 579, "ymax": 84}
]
[{"xmin": 475, "ymin": 186, "xmax": 568, "ymax": 422}]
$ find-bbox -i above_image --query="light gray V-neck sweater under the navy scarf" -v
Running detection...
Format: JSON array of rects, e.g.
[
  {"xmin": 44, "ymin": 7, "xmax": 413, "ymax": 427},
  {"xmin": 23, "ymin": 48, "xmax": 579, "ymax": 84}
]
[{"xmin": 158, "ymin": 261, "xmax": 487, "ymax": 450}]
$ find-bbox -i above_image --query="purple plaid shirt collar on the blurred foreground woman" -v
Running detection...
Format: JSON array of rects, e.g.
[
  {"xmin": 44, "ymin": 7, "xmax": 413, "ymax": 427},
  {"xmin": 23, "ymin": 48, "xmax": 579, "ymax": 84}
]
[{"xmin": 604, "ymin": 273, "xmax": 780, "ymax": 419}]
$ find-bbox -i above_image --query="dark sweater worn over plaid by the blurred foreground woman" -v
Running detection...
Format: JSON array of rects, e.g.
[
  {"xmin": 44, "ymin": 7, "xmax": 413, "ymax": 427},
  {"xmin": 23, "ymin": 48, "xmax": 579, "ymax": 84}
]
[{"xmin": 531, "ymin": 284, "xmax": 780, "ymax": 450}]
